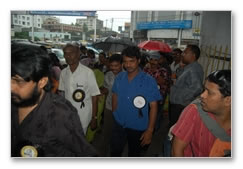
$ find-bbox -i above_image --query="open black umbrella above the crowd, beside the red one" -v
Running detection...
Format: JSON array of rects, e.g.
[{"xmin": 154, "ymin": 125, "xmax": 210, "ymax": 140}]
[{"xmin": 93, "ymin": 36, "xmax": 135, "ymax": 53}]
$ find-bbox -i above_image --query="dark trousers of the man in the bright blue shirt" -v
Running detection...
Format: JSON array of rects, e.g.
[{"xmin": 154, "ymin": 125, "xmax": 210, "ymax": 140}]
[{"xmin": 111, "ymin": 119, "xmax": 148, "ymax": 157}]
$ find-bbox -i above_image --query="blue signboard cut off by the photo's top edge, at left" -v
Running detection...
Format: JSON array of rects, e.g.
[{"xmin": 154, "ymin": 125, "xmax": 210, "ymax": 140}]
[{"xmin": 29, "ymin": 11, "xmax": 96, "ymax": 16}]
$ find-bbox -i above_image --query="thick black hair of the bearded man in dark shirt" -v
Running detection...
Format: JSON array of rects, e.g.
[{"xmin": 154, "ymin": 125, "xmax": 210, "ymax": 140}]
[{"xmin": 11, "ymin": 46, "xmax": 51, "ymax": 91}]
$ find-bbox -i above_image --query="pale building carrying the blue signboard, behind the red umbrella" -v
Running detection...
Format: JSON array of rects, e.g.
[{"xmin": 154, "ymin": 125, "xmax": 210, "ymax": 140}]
[{"xmin": 130, "ymin": 11, "xmax": 202, "ymax": 44}]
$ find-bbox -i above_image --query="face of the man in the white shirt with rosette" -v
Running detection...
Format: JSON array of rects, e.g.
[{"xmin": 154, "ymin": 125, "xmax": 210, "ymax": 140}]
[{"xmin": 63, "ymin": 46, "xmax": 80, "ymax": 66}]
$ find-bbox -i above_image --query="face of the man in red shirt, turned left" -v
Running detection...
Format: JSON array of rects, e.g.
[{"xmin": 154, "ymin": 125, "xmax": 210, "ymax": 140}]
[{"xmin": 200, "ymin": 81, "xmax": 230, "ymax": 114}]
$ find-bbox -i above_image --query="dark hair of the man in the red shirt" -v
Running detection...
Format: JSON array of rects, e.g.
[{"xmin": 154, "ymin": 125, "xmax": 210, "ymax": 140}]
[{"xmin": 206, "ymin": 70, "xmax": 231, "ymax": 97}]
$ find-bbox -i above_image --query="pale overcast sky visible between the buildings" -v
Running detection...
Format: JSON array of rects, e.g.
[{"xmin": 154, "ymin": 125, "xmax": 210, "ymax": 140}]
[{"xmin": 58, "ymin": 11, "xmax": 131, "ymax": 31}]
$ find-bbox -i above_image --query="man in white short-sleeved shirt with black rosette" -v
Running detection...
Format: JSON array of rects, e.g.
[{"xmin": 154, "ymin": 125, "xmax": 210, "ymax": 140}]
[{"xmin": 58, "ymin": 44, "xmax": 100, "ymax": 134}]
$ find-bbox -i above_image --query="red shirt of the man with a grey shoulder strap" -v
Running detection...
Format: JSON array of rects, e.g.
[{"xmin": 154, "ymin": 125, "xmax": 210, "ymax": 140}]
[{"xmin": 172, "ymin": 104, "xmax": 231, "ymax": 157}]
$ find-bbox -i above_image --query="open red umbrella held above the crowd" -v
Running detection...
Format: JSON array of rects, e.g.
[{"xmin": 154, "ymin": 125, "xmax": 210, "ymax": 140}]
[{"xmin": 138, "ymin": 40, "xmax": 172, "ymax": 52}]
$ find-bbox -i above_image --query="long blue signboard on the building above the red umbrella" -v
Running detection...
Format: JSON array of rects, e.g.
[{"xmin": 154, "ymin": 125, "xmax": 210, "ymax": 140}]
[{"xmin": 137, "ymin": 20, "xmax": 192, "ymax": 30}]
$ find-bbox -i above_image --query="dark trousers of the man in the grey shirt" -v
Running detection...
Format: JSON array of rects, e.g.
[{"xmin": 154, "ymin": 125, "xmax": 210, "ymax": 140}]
[{"xmin": 169, "ymin": 103, "xmax": 185, "ymax": 128}]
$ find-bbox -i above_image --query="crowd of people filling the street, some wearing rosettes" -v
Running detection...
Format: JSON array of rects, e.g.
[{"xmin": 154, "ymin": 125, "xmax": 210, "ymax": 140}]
[{"xmin": 11, "ymin": 43, "xmax": 231, "ymax": 157}]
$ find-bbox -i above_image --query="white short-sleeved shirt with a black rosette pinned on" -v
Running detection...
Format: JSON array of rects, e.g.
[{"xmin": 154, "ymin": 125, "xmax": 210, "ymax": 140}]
[{"xmin": 58, "ymin": 63, "xmax": 100, "ymax": 133}]
